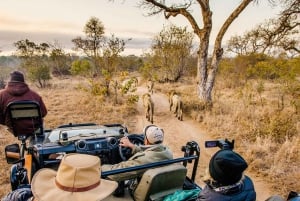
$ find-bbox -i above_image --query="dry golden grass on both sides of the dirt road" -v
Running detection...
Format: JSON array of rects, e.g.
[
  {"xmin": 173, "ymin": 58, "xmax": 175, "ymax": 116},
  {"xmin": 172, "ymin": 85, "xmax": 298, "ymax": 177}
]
[{"xmin": 0, "ymin": 75, "xmax": 300, "ymax": 197}]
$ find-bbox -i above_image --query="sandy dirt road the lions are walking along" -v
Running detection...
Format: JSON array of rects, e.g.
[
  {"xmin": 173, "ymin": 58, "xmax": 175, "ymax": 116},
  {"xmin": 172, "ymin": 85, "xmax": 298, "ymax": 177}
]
[{"xmin": 128, "ymin": 87, "xmax": 271, "ymax": 201}]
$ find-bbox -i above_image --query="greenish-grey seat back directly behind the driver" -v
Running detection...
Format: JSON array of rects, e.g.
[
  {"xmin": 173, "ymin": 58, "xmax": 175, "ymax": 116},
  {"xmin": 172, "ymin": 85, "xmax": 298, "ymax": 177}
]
[{"xmin": 133, "ymin": 164, "xmax": 187, "ymax": 201}]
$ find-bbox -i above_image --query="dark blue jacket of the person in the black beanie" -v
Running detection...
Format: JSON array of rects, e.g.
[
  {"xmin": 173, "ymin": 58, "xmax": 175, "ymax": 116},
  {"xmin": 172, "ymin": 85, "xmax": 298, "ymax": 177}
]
[{"xmin": 197, "ymin": 176, "xmax": 256, "ymax": 201}]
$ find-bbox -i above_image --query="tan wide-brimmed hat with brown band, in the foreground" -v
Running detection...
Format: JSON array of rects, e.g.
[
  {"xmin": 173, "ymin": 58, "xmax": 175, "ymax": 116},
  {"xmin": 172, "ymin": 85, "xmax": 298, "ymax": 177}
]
[{"xmin": 31, "ymin": 153, "xmax": 118, "ymax": 201}]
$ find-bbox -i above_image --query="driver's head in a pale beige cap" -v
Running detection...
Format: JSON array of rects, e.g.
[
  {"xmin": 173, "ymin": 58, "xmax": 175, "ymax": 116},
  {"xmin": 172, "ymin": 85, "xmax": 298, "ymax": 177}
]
[{"xmin": 143, "ymin": 125, "xmax": 164, "ymax": 145}]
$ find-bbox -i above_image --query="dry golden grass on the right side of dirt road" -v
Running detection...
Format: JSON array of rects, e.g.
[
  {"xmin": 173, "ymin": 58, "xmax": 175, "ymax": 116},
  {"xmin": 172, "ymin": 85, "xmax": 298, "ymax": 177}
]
[{"xmin": 157, "ymin": 75, "xmax": 300, "ymax": 197}]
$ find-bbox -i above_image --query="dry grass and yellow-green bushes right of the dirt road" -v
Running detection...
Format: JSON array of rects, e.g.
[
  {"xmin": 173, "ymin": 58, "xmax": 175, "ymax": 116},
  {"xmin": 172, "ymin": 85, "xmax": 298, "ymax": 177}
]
[{"xmin": 160, "ymin": 55, "xmax": 300, "ymax": 196}]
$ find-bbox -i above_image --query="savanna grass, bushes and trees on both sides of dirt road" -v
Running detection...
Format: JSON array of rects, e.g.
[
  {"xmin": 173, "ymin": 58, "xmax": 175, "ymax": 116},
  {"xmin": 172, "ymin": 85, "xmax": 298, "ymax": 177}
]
[{"xmin": 0, "ymin": 0, "xmax": 300, "ymax": 196}]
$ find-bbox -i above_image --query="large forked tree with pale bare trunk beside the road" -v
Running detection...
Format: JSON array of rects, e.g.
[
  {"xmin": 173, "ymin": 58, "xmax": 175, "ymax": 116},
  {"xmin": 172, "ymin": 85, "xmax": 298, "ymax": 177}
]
[{"xmin": 136, "ymin": 0, "xmax": 254, "ymax": 105}]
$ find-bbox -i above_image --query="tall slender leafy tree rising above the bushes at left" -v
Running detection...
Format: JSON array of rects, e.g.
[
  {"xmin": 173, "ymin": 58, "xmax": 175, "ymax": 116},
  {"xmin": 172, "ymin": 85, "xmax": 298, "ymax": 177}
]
[{"xmin": 72, "ymin": 17, "xmax": 105, "ymax": 72}]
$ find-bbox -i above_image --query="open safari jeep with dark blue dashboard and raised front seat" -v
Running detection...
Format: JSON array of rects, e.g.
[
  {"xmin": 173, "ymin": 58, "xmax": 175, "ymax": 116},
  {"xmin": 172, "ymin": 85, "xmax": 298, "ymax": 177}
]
[{"xmin": 5, "ymin": 101, "xmax": 200, "ymax": 201}]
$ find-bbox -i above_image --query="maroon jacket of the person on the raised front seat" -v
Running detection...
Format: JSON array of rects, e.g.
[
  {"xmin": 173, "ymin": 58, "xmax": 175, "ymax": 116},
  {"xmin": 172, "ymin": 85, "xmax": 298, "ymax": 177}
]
[{"xmin": 0, "ymin": 82, "xmax": 47, "ymax": 135}]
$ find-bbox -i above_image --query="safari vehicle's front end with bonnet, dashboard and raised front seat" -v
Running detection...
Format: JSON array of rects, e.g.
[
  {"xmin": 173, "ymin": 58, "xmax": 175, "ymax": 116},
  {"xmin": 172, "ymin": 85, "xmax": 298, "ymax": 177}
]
[{"xmin": 5, "ymin": 101, "xmax": 144, "ymax": 190}]
